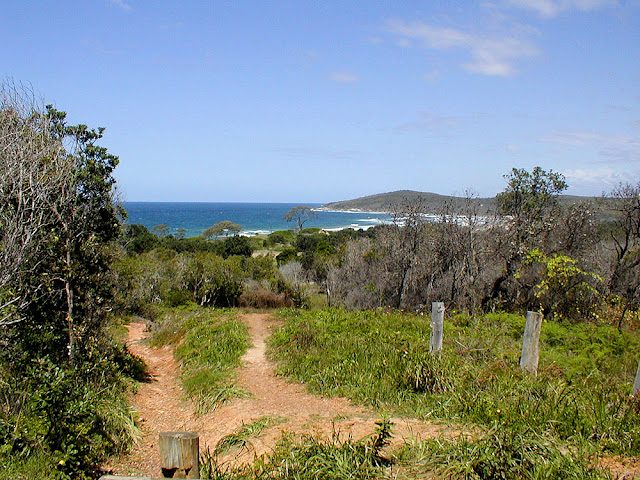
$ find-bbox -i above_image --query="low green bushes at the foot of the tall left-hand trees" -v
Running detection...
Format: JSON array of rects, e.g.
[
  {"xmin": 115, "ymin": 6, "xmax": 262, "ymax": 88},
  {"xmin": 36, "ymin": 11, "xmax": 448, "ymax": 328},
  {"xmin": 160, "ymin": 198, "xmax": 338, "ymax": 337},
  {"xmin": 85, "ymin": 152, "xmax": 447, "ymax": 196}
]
[{"xmin": 0, "ymin": 353, "xmax": 139, "ymax": 478}]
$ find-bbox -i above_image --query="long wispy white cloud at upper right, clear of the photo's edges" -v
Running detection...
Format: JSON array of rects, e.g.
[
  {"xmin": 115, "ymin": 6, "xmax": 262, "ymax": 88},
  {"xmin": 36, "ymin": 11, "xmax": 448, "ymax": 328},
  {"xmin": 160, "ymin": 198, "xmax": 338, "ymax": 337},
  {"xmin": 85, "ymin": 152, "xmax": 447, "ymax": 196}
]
[{"xmin": 386, "ymin": 20, "xmax": 540, "ymax": 76}]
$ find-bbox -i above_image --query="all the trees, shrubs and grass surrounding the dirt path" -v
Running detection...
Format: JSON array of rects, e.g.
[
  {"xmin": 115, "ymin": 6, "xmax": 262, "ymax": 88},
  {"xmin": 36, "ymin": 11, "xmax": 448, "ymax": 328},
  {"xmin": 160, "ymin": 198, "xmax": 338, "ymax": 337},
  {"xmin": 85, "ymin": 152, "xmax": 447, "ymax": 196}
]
[{"xmin": 0, "ymin": 80, "xmax": 640, "ymax": 478}]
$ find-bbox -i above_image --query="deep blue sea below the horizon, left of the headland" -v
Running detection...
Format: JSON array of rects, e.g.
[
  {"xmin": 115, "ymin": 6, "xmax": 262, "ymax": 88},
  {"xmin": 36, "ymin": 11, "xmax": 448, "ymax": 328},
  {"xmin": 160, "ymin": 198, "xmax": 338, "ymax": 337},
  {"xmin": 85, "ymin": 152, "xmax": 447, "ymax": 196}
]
[{"xmin": 124, "ymin": 202, "xmax": 390, "ymax": 237}]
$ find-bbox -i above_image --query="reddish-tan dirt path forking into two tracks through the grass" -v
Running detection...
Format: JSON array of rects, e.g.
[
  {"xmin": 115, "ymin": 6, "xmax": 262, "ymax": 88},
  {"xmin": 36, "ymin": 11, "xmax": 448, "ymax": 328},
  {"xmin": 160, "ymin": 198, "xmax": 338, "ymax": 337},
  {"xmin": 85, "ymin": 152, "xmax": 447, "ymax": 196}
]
[{"xmin": 106, "ymin": 313, "xmax": 445, "ymax": 475}]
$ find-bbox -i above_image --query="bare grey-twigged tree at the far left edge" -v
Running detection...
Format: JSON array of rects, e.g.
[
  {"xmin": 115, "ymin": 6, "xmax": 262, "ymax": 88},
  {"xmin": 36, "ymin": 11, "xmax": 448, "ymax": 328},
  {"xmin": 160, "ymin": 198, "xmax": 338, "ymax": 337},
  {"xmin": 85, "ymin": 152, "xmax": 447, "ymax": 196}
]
[{"xmin": 0, "ymin": 83, "xmax": 67, "ymax": 326}]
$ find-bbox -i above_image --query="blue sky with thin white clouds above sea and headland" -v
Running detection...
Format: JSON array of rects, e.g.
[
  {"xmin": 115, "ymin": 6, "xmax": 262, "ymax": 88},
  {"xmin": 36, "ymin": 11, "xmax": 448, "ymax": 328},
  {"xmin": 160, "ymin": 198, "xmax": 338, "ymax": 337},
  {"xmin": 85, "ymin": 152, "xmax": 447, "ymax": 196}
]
[{"xmin": 0, "ymin": 0, "xmax": 640, "ymax": 203}]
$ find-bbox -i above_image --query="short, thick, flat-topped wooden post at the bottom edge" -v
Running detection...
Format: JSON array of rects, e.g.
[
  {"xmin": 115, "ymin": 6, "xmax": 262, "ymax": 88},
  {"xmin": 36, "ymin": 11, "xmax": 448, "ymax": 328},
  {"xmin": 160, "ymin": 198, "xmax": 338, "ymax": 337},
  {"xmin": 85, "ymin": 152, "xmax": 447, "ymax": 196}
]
[{"xmin": 160, "ymin": 432, "xmax": 200, "ymax": 478}]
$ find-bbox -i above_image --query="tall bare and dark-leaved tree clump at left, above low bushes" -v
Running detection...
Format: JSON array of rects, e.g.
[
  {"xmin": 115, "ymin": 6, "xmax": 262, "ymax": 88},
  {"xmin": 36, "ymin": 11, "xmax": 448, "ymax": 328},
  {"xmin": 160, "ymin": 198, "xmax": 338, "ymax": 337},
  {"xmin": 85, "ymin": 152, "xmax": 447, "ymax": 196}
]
[{"xmin": 0, "ymin": 81, "xmax": 124, "ymax": 365}]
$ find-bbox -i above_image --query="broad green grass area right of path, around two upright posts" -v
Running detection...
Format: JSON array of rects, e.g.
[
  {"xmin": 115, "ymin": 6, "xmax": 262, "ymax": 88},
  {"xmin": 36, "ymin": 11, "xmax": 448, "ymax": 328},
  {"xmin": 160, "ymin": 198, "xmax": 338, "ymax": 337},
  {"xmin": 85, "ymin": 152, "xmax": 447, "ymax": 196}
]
[{"xmin": 270, "ymin": 309, "xmax": 640, "ymax": 455}]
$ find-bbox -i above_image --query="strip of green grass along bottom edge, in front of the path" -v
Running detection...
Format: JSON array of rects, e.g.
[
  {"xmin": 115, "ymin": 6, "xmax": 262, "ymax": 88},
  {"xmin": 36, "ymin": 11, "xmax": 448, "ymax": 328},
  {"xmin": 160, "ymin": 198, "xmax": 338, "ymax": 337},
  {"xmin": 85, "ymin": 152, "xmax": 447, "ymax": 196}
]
[{"xmin": 201, "ymin": 420, "xmax": 611, "ymax": 480}]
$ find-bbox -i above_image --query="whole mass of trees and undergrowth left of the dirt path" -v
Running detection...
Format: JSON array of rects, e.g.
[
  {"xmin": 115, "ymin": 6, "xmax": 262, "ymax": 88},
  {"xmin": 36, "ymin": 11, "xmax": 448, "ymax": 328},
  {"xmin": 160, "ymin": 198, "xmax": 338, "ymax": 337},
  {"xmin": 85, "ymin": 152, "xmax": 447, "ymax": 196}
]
[{"xmin": 0, "ymin": 82, "xmax": 144, "ymax": 478}]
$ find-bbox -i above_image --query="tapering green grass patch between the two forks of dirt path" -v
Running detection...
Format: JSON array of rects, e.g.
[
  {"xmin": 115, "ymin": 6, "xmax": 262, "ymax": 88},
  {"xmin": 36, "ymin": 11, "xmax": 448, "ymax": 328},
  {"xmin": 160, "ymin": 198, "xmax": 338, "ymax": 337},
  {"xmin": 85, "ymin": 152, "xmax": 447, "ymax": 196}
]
[{"xmin": 151, "ymin": 305, "xmax": 249, "ymax": 413}]
